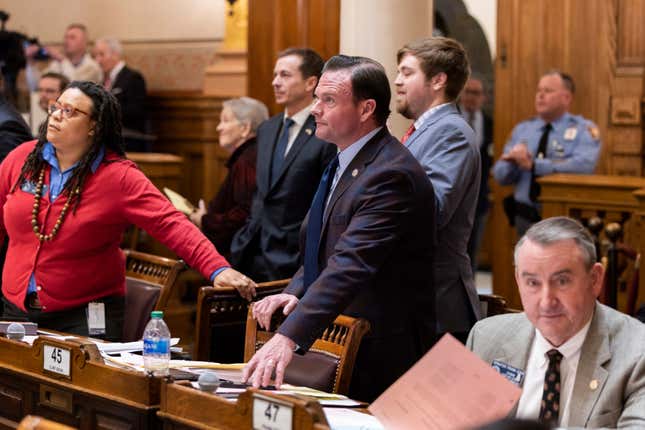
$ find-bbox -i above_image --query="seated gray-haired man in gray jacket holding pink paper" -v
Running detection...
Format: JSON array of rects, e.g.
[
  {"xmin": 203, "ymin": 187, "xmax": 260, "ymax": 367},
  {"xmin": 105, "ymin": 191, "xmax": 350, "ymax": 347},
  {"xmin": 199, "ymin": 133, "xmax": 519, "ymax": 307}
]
[{"xmin": 467, "ymin": 217, "xmax": 645, "ymax": 429}]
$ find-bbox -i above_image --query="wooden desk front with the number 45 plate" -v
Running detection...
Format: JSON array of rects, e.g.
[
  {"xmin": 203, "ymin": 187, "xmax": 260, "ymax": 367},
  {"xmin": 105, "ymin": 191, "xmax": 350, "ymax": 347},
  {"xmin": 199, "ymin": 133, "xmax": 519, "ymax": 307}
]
[{"xmin": 0, "ymin": 337, "xmax": 161, "ymax": 430}]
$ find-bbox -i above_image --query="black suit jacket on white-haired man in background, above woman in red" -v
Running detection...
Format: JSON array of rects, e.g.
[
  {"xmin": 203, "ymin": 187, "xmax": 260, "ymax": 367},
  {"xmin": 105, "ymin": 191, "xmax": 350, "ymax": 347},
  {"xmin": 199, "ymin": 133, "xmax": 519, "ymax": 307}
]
[{"xmin": 110, "ymin": 66, "xmax": 146, "ymax": 133}]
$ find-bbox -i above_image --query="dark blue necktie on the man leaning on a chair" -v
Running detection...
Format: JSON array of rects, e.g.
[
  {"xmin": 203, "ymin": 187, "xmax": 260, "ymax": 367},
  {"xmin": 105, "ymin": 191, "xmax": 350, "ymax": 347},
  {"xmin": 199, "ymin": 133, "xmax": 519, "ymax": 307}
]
[{"xmin": 304, "ymin": 156, "xmax": 338, "ymax": 289}]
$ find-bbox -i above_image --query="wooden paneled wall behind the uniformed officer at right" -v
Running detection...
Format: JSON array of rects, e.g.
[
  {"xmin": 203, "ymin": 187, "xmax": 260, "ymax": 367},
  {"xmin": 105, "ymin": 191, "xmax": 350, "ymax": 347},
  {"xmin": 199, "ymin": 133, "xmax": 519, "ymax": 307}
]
[{"xmin": 492, "ymin": 0, "xmax": 645, "ymax": 307}]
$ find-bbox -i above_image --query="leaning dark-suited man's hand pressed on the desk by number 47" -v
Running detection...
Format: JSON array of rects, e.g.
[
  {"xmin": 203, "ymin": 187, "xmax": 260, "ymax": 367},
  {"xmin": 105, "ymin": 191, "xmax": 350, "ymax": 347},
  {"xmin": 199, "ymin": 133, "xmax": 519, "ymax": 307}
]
[{"xmin": 242, "ymin": 333, "xmax": 296, "ymax": 388}]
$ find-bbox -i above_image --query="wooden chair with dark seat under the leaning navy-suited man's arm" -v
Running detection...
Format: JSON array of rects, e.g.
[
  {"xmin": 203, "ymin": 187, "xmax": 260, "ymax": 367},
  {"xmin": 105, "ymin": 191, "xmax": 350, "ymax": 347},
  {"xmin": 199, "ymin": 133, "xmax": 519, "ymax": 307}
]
[{"xmin": 244, "ymin": 309, "xmax": 370, "ymax": 394}]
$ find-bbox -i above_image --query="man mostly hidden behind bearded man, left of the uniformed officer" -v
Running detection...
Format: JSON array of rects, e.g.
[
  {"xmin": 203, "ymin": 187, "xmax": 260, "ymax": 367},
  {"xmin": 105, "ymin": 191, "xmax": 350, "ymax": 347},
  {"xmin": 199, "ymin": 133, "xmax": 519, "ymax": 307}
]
[{"xmin": 460, "ymin": 76, "xmax": 493, "ymax": 273}]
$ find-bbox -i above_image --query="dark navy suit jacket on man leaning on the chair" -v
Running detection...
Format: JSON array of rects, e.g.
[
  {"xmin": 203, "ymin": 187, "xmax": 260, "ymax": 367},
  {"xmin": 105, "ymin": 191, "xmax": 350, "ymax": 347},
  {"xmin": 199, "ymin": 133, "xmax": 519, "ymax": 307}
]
[{"xmin": 278, "ymin": 128, "xmax": 435, "ymax": 401}]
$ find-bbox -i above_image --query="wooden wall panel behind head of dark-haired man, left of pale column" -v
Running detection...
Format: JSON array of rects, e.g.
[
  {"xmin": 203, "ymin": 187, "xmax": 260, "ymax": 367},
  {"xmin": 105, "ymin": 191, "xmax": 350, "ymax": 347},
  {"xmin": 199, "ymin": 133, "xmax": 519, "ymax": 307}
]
[{"xmin": 248, "ymin": 0, "xmax": 340, "ymax": 114}]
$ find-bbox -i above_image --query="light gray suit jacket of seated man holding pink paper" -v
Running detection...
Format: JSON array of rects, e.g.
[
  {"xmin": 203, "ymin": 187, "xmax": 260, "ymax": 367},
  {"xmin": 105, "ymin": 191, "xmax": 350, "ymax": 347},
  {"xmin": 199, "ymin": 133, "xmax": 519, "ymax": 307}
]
[{"xmin": 467, "ymin": 304, "xmax": 645, "ymax": 429}]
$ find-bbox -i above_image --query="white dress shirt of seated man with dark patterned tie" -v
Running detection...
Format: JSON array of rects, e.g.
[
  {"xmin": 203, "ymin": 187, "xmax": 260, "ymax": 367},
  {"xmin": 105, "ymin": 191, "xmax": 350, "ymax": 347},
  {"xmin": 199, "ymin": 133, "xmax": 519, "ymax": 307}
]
[{"xmin": 516, "ymin": 318, "xmax": 591, "ymax": 427}]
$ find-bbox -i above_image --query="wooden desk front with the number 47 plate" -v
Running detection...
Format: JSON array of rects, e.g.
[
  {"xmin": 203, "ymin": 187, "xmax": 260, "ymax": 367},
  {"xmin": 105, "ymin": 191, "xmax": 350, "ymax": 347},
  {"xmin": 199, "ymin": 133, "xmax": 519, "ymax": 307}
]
[{"xmin": 157, "ymin": 382, "xmax": 329, "ymax": 430}]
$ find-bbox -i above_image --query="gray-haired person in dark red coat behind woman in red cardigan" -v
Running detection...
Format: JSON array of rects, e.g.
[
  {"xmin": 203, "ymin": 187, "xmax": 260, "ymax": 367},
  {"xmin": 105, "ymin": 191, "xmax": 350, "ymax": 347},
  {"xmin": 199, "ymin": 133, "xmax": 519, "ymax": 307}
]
[{"xmin": 190, "ymin": 97, "xmax": 269, "ymax": 256}]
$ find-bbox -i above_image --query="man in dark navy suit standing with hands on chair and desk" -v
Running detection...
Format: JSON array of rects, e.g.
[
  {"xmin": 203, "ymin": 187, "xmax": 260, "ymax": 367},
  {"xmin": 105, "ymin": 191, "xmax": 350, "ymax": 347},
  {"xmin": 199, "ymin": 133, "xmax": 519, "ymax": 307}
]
[{"xmin": 244, "ymin": 55, "xmax": 435, "ymax": 401}]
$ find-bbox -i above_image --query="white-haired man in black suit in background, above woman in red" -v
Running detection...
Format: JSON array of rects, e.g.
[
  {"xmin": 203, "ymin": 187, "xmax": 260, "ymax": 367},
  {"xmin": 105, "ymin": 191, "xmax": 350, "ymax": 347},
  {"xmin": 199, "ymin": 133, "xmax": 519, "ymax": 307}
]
[{"xmin": 94, "ymin": 38, "xmax": 150, "ymax": 151}]
